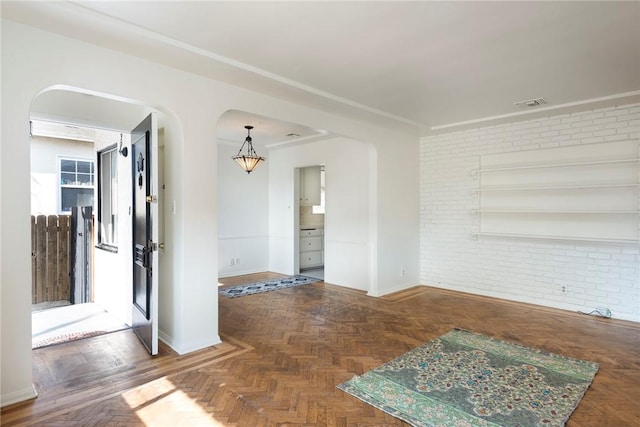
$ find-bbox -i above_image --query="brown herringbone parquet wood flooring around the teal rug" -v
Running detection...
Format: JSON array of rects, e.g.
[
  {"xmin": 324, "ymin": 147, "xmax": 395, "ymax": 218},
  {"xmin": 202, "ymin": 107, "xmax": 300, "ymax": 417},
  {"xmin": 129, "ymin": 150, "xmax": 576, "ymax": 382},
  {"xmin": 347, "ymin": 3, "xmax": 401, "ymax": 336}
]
[{"xmin": 1, "ymin": 273, "xmax": 640, "ymax": 427}]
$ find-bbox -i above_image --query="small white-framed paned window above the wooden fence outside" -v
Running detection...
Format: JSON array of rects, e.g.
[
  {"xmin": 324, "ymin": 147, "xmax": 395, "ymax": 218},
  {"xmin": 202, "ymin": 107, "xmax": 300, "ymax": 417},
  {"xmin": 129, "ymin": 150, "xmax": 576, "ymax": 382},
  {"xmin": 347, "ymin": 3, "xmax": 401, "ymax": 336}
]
[{"xmin": 60, "ymin": 158, "xmax": 95, "ymax": 213}]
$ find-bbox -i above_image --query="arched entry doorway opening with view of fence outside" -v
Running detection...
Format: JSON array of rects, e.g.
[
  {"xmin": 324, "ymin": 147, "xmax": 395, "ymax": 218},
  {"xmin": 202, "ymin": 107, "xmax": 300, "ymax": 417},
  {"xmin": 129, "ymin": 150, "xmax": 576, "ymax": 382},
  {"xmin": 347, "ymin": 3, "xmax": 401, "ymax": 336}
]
[{"xmin": 30, "ymin": 87, "xmax": 174, "ymax": 347}]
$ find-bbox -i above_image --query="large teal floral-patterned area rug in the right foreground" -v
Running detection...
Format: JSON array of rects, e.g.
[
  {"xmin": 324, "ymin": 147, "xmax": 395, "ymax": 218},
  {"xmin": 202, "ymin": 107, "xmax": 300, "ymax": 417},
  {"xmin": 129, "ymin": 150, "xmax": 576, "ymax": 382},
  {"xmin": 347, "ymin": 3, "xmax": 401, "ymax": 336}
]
[{"xmin": 338, "ymin": 329, "xmax": 598, "ymax": 427}]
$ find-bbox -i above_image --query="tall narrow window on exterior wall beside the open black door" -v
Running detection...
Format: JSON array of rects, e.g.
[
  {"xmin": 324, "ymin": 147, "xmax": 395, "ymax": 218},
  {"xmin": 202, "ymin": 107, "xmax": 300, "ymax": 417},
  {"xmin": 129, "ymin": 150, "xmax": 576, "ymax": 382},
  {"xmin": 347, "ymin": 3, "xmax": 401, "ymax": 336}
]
[{"xmin": 98, "ymin": 145, "xmax": 118, "ymax": 249}]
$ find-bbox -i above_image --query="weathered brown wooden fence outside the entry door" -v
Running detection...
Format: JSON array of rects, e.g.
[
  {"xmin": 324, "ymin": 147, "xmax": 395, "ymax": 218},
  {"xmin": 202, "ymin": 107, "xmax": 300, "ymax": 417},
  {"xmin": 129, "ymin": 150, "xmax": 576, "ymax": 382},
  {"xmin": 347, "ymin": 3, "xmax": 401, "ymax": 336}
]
[{"xmin": 31, "ymin": 215, "xmax": 71, "ymax": 304}]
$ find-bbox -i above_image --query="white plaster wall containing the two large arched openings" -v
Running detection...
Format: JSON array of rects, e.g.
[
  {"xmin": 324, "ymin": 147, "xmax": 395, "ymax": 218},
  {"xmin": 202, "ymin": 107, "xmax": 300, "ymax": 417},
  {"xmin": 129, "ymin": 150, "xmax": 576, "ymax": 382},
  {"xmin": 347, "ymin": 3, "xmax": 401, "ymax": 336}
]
[{"xmin": 0, "ymin": 20, "xmax": 419, "ymax": 405}]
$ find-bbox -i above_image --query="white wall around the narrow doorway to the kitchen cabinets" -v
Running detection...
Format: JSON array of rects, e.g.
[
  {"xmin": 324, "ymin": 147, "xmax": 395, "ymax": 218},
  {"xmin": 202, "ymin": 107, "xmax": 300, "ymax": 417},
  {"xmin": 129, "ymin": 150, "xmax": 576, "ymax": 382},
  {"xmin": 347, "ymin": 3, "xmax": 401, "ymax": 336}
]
[{"xmin": 269, "ymin": 138, "xmax": 375, "ymax": 290}]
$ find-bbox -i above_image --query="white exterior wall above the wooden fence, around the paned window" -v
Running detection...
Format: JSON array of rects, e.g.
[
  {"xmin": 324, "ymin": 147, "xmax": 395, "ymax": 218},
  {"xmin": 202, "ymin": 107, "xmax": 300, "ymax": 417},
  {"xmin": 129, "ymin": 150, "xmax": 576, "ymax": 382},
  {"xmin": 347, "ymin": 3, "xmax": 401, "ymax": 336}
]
[{"xmin": 31, "ymin": 136, "xmax": 94, "ymax": 215}]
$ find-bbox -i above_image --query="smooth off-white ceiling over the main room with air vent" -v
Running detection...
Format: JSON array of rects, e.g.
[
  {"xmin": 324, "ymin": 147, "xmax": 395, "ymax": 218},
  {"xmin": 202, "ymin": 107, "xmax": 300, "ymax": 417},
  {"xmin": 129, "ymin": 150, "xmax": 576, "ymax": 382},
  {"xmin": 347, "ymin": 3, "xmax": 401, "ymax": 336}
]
[{"xmin": 2, "ymin": 1, "xmax": 640, "ymax": 144}]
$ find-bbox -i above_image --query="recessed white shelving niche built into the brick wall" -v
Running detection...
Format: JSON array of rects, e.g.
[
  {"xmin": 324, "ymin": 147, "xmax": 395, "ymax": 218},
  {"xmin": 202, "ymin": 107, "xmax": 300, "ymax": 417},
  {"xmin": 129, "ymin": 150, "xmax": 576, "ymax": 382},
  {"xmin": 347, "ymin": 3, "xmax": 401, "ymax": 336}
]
[{"xmin": 473, "ymin": 141, "xmax": 640, "ymax": 245}]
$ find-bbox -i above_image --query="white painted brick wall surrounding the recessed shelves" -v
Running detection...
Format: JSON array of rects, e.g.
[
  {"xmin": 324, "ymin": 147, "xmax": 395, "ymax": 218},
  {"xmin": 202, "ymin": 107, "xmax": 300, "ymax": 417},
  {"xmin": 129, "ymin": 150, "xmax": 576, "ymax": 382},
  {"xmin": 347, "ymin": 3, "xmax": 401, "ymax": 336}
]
[{"xmin": 420, "ymin": 104, "xmax": 640, "ymax": 322}]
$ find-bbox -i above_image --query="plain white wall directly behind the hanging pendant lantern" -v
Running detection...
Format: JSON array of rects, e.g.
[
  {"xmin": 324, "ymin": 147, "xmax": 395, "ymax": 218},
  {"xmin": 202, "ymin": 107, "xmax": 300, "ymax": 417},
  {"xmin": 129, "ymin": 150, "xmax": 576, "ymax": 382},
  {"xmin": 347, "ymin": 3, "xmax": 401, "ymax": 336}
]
[{"xmin": 217, "ymin": 142, "xmax": 271, "ymax": 277}]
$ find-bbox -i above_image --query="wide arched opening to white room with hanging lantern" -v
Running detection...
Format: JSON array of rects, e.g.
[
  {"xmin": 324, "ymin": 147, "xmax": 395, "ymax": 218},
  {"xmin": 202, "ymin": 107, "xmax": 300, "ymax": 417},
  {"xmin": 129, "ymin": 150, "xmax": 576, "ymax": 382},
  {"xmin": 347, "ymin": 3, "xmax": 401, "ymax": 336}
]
[{"xmin": 217, "ymin": 110, "xmax": 376, "ymax": 292}]
